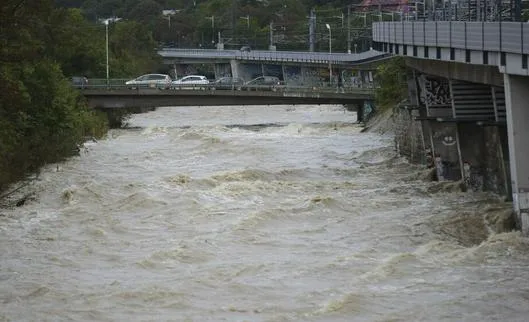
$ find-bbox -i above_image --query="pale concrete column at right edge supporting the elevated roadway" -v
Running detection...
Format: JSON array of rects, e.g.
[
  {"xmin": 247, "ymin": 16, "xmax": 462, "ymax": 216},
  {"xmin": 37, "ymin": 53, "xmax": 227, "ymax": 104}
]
[{"xmin": 504, "ymin": 74, "xmax": 529, "ymax": 236}]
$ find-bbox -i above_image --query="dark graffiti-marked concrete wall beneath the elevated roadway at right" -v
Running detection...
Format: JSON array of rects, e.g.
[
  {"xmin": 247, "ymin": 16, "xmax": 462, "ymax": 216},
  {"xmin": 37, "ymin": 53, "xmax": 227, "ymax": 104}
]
[{"xmin": 394, "ymin": 70, "xmax": 511, "ymax": 199}]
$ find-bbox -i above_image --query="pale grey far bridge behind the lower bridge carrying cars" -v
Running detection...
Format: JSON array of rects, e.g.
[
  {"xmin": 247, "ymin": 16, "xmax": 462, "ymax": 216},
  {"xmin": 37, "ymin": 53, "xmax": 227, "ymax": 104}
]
[{"xmin": 158, "ymin": 48, "xmax": 390, "ymax": 87}]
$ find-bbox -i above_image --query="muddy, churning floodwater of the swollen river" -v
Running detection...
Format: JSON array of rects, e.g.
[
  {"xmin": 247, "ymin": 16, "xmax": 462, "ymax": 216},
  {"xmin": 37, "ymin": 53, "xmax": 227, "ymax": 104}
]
[{"xmin": 0, "ymin": 106, "xmax": 529, "ymax": 321}]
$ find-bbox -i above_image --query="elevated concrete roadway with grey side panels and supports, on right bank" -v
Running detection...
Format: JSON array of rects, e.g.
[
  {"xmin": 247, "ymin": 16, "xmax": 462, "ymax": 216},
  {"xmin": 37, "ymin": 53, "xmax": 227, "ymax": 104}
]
[{"xmin": 373, "ymin": 13, "xmax": 529, "ymax": 235}]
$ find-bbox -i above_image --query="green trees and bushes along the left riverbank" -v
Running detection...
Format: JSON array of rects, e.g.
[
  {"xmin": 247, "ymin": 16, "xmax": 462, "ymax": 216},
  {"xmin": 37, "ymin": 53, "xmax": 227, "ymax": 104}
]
[{"xmin": 0, "ymin": 0, "xmax": 159, "ymax": 195}]
